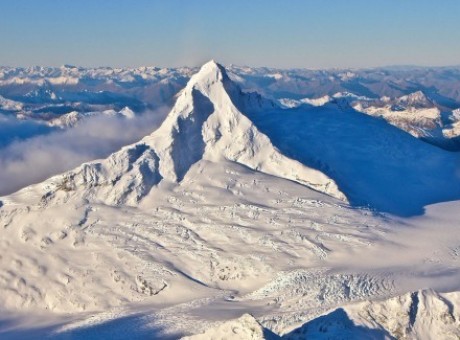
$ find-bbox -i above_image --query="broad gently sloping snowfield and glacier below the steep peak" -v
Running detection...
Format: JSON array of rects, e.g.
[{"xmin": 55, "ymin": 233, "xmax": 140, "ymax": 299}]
[{"xmin": 1, "ymin": 195, "xmax": 460, "ymax": 339}]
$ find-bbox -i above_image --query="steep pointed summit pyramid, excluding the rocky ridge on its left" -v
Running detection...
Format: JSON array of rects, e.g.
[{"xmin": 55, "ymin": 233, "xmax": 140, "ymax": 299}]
[{"xmin": 145, "ymin": 61, "xmax": 344, "ymax": 199}]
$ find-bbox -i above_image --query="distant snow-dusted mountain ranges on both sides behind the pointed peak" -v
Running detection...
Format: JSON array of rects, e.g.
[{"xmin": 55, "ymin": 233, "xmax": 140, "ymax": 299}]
[{"xmin": 0, "ymin": 66, "xmax": 460, "ymax": 150}]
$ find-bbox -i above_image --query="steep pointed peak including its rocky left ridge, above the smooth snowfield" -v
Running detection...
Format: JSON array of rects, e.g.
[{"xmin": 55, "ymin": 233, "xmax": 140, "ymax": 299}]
[{"xmin": 7, "ymin": 61, "xmax": 345, "ymax": 204}]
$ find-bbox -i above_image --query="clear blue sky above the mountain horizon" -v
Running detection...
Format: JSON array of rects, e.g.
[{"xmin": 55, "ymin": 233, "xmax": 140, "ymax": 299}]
[{"xmin": 0, "ymin": 0, "xmax": 460, "ymax": 68}]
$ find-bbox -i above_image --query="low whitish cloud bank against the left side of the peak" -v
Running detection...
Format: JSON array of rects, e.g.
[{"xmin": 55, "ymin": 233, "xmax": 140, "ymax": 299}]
[{"xmin": 0, "ymin": 109, "xmax": 166, "ymax": 195}]
